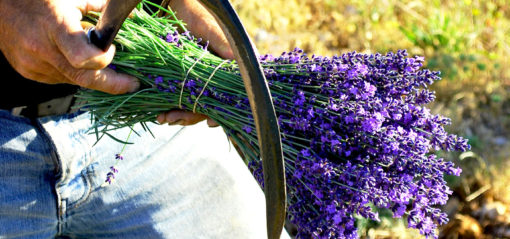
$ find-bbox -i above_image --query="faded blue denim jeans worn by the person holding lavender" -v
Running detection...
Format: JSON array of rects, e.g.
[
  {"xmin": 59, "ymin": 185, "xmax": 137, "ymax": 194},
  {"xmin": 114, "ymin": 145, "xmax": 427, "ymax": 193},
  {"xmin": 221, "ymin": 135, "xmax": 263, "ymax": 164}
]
[{"xmin": 0, "ymin": 110, "xmax": 288, "ymax": 239}]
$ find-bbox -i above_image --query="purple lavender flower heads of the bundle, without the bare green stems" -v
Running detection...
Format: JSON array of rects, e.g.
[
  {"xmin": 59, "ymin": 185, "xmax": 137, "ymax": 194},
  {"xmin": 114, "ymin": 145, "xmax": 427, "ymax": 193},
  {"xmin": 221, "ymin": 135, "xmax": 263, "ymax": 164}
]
[{"xmin": 141, "ymin": 49, "xmax": 469, "ymax": 238}]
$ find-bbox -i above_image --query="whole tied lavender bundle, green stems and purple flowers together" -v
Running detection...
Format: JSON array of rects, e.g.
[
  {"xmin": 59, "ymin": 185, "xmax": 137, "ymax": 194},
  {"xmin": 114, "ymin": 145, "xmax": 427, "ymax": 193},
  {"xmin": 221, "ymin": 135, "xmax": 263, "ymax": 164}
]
[{"xmin": 78, "ymin": 2, "xmax": 469, "ymax": 238}]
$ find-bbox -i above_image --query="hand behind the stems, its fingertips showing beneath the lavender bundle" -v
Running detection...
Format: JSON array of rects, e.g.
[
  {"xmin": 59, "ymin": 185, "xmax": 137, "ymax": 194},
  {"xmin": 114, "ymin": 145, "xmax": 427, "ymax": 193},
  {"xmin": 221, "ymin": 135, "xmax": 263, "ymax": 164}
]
[{"xmin": 157, "ymin": 0, "xmax": 234, "ymax": 126}]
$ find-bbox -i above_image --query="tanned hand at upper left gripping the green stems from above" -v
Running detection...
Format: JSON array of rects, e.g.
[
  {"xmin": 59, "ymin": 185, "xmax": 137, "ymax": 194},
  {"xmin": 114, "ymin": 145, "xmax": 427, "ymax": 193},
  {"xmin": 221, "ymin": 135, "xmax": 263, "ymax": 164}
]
[{"xmin": 0, "ymin": 0, "xmax": 139, "ymax": 94}]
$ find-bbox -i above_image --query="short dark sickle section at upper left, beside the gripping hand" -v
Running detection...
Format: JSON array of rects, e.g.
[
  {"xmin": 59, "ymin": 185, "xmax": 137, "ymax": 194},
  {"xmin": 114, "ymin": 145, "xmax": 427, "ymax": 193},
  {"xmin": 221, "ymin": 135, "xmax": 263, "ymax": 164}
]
[{"xmin": 88, "ymin": 0, "xmax": 141, "ymax": 51}]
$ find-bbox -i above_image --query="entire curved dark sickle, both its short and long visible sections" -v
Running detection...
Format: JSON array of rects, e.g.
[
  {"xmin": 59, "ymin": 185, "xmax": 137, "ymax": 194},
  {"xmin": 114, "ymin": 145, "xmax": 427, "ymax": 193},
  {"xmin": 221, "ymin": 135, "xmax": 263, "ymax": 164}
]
[{"xmin": 88, "ymin": 0, "xmax": 287, "ymax": 239}]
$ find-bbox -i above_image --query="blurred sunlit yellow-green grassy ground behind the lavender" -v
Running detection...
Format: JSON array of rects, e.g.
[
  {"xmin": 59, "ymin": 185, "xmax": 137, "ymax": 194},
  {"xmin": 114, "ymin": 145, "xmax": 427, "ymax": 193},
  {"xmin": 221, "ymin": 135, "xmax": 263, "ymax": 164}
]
[{"xmin": 231, "ymin": 0, "xmax": 510, "ymax": 238}]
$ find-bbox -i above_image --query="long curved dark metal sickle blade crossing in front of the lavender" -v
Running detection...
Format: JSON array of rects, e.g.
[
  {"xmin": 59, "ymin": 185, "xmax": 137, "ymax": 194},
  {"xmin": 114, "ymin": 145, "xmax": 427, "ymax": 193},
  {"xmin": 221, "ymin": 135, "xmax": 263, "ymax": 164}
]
[{"xmin": 201, "ymin": 0, "xmax": 287, "ymax": 239}]
